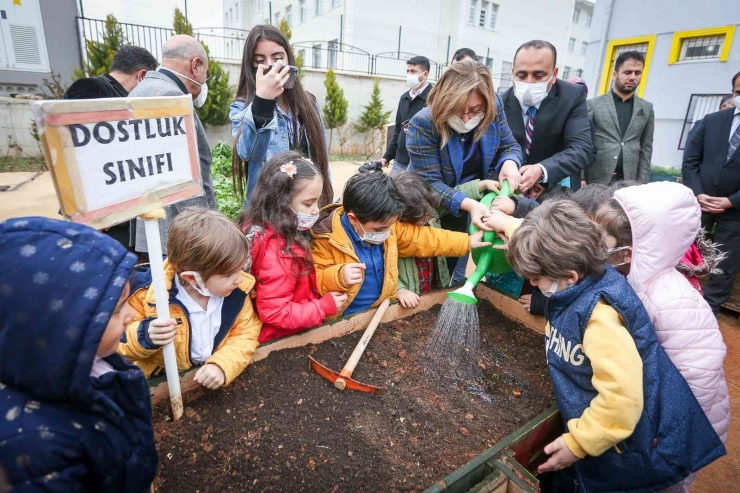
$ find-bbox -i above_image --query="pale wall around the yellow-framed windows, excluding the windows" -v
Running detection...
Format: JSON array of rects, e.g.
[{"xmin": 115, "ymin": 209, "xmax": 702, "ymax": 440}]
[{"xmin": 584, "ymin": 0, "xmax": 740, "ymax": 168}]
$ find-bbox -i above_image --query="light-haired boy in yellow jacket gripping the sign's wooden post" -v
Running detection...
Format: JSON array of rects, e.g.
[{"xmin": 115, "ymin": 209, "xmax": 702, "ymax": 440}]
[{"xmin": 118, "ymin": 208, "xmax": 262, "ymax": 389}]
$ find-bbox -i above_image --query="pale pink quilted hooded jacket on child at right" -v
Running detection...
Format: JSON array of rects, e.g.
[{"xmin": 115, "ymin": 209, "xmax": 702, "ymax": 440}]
[{"xmin": 614, "ymin": 182, "xmax": 730, "ymax": 442}]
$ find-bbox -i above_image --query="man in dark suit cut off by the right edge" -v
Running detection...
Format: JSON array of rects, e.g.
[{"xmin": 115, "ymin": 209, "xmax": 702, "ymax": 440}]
[{"xmin": 682, "ymin": 72, "xmax": 740, "ymax": 313}]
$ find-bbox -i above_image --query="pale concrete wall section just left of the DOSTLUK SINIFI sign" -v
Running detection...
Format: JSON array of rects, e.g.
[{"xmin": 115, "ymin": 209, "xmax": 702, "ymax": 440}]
[{"xmin": 0, "ymin": 97, "xmax": 41, "ymax": 157}]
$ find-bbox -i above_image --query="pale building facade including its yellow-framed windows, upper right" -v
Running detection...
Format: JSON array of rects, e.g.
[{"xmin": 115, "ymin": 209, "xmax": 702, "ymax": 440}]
[{"xmin": 584, "ymin": 0, "xmax": 740, "ymax": 168}]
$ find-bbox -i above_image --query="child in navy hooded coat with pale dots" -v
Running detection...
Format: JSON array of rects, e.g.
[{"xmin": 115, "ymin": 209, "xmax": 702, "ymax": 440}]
[{"xmin": 0, "ymin": 217, "xmax": 157, "ymax": 493}]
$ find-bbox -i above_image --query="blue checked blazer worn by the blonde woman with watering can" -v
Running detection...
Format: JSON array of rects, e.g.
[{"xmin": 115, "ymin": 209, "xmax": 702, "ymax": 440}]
[{"xmin": 406, "ymin": 96, "xmax": 522, "ymax": 216}]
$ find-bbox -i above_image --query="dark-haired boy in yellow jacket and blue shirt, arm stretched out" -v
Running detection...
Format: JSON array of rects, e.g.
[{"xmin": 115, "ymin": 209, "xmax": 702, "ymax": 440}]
[{"xmin": 311, "ymin": 169, "xmax": 490, "ymax": 315}]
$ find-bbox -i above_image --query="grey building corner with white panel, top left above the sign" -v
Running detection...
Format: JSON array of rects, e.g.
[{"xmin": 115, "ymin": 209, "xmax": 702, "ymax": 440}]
[{"xmin": 0, "ymin": 0, "xmax": 81, "ymax": 96}]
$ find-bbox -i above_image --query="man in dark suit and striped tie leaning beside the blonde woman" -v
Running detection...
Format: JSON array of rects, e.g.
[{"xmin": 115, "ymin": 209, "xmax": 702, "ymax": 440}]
[{"xmin": 503, "ymin": 40, "xmax": 594, "ymax": 191}]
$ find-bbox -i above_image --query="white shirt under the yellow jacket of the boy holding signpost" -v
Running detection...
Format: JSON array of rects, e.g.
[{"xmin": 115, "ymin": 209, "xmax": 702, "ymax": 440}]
[{"xmin": 174, "ymin": 276, "xmax": 224, "ymax": 364}]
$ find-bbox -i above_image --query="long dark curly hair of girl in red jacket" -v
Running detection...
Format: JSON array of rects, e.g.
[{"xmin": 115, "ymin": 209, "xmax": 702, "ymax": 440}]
[{"xmin": 238, "ymin": 151, "xmax": 323, "ymax": 275}]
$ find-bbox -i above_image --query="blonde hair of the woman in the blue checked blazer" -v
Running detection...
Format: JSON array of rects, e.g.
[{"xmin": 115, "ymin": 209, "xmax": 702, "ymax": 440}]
[{"xmin": 427, "ymin": 60, "xmax": 497, "ymax": 147}]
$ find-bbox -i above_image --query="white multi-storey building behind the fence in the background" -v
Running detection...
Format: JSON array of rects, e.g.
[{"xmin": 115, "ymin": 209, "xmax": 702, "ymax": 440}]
[{"xmin": 223, "ymin": 0, "xmax": 593, "ymax": 88}]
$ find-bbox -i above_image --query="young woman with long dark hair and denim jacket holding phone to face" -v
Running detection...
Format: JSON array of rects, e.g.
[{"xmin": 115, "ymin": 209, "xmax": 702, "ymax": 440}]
[{"xmin": 229, "ymin": 25, "xmax": 334, "ymax": 208}]
